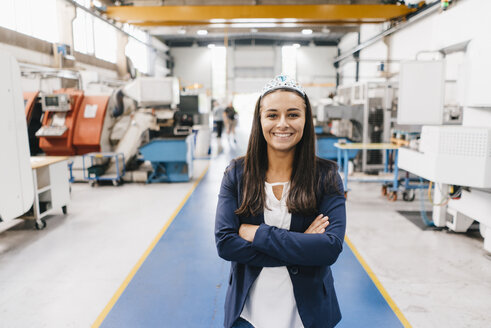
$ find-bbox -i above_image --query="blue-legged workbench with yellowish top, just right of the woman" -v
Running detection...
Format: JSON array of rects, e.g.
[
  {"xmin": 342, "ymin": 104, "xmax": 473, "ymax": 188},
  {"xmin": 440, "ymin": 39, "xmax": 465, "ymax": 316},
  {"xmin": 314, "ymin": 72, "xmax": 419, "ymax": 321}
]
[{"xmin": 334, "ymin": 143, "xmax": 399, "ymax": 200}]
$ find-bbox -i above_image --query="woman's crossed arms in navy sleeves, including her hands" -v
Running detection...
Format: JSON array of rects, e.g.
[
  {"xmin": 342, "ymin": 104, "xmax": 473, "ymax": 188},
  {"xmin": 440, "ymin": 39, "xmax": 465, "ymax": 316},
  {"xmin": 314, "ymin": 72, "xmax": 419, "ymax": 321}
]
[{"xmin": 215, "ymin": 172, "xmax": 346, "ymax": 267}]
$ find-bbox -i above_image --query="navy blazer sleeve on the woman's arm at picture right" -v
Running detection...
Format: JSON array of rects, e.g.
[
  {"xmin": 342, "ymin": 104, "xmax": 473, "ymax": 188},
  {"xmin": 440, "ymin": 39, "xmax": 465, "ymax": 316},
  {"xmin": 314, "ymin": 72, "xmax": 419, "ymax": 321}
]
[{"xmin": 252, "ymin": 174, "xmax": 346, "ymax": 266}]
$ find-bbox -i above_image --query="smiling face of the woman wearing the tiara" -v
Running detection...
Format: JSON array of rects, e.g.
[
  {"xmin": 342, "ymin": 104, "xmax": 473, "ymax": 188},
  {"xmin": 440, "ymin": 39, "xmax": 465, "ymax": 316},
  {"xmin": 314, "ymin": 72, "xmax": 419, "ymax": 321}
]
[{"xmin": 260, "ymin": 90, "xmax": 305, "ymax": 152}]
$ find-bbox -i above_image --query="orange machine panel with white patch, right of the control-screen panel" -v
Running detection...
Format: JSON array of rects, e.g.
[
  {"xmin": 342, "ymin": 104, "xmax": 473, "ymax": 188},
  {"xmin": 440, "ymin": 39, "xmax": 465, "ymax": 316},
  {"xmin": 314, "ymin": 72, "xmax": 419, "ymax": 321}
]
[{"xmin": 73, "ymin": 96, "xmax": 110, "ymax": 155}]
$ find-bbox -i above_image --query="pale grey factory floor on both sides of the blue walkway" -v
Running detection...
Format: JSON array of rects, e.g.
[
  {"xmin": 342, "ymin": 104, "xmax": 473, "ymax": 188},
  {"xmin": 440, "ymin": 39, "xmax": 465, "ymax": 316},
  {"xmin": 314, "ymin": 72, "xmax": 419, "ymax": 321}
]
[{"xmin": 0, "ymin": 152, "xmax": 491, "ymax": 328}]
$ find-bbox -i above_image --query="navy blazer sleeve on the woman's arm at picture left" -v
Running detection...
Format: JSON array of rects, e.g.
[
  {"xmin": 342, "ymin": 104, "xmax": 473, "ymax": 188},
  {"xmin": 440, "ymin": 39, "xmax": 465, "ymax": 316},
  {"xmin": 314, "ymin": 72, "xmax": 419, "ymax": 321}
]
[{"xmin": 215, "ymin": 163, "xmax": 288, "ymax": 267}]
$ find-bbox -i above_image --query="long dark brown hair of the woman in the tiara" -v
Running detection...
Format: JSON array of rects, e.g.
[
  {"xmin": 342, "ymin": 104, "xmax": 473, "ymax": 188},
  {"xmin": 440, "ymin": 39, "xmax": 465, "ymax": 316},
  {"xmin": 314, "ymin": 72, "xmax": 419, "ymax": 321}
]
[{"xmin": 235, "ymin": 89, "xmax": 319, "ymax": 217}]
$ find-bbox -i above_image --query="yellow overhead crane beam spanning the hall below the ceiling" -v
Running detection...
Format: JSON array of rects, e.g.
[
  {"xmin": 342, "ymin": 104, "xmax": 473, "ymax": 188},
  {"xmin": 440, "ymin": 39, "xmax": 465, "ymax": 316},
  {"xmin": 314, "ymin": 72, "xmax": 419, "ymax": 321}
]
[{"xmin": 106, "ymin": 5, "xmax": 415, "ymax": 26}]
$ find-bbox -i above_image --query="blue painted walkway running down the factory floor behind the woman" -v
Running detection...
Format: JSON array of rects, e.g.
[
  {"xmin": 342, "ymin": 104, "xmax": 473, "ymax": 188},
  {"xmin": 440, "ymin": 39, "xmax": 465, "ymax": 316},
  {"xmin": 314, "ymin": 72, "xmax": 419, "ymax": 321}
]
[{"xmin": 101, "ymin": 154, "xmax": 405, "ymax": 327}]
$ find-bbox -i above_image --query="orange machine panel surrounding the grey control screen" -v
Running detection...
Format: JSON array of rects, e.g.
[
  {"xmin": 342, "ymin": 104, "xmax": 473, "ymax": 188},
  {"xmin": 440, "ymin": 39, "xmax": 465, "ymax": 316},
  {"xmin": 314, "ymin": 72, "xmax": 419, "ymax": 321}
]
[{"xmin": 39, "ymin": 89, "xmax": 84, "ymax": 156}]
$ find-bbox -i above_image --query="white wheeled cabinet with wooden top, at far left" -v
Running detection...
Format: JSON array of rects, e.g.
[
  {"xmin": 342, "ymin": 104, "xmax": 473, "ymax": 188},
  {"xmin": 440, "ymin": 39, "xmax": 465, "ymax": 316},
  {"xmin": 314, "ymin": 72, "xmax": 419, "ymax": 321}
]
[{"xmin": 22, "ymin": 156, "xmax": 70, "ymax": 229}]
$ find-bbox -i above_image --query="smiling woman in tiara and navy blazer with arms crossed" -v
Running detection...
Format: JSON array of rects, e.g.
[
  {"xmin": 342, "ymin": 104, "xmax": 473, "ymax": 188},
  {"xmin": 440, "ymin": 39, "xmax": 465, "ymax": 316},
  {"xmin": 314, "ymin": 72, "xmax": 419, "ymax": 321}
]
[{"xmin": 215, "ymin": 75, "xmax": 346, "ymax": 328}]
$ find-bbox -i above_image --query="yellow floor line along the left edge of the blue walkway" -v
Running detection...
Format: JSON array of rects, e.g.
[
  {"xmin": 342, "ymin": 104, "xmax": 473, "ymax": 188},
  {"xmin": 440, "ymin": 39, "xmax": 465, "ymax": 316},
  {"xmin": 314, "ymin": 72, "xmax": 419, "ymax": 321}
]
[{"xmin": 92, "ymin": 163, "xmax": 210, "ymax": 328}]
